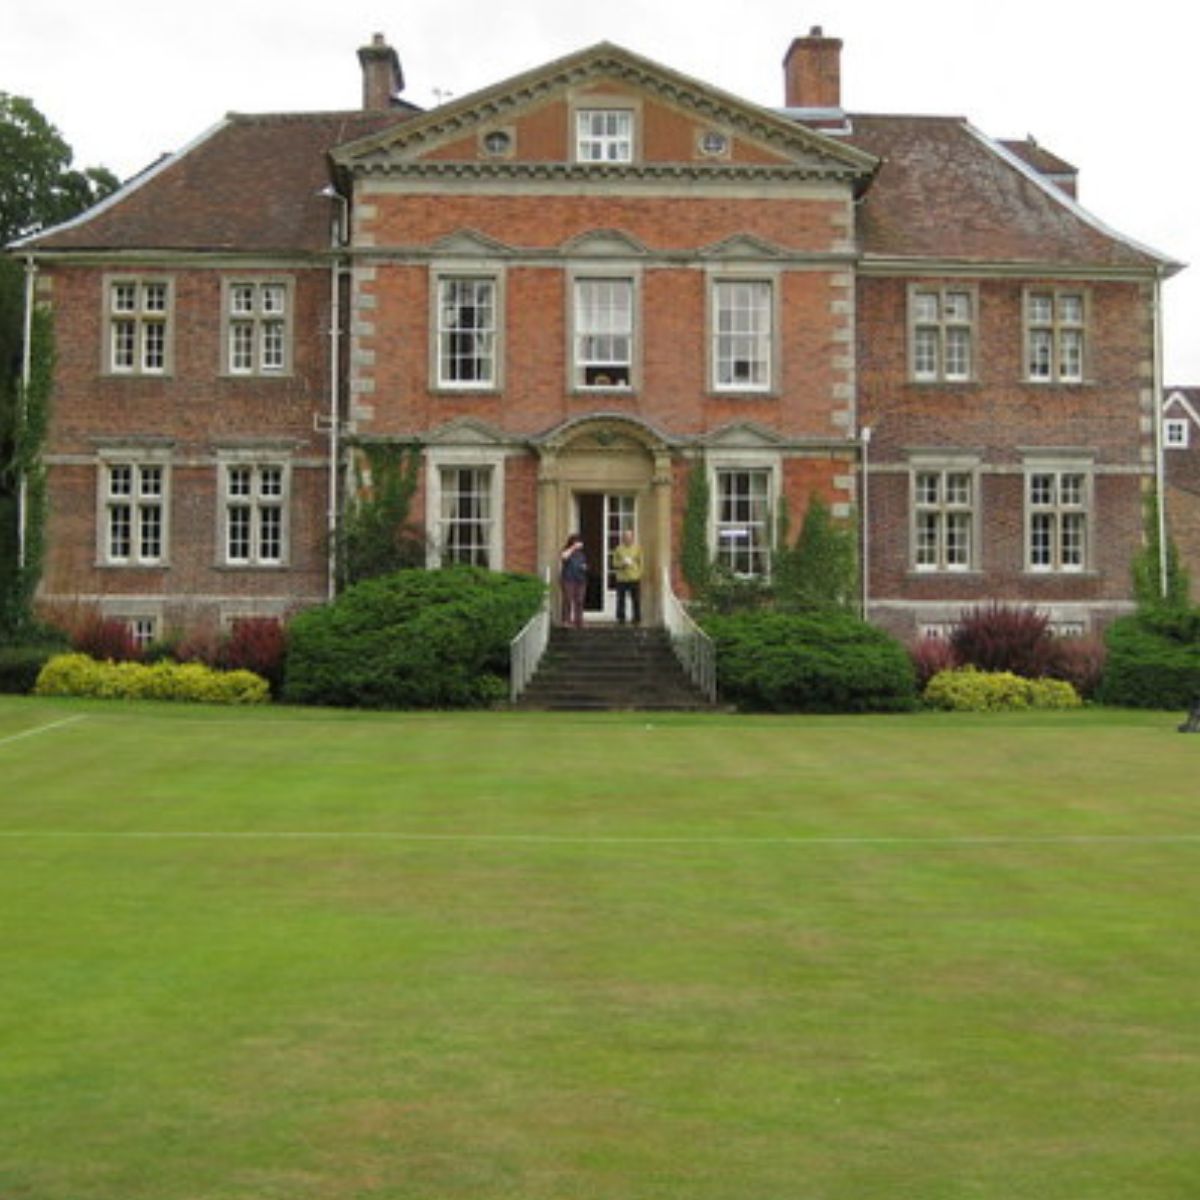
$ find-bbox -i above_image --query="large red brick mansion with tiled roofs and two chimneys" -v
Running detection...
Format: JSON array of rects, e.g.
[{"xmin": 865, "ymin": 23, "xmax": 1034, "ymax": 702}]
[{"xmin": 9, "ymin": 31, "xmax": 1174, "ymax": 635}]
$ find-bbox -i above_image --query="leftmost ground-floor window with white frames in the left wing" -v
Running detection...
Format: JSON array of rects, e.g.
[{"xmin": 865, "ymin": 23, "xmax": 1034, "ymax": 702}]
[{"xmin": 100, "ymin": 456, "xmax": 169, "ymax": 566}]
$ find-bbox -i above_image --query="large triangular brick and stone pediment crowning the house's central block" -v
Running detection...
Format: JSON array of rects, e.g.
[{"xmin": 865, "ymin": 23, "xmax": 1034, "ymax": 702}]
[{"xmin": 334, "ymin": 42, "xmax": 877, "ymax": 186}]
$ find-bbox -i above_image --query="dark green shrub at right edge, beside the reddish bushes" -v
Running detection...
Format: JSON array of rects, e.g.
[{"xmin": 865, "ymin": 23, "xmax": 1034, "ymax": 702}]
[{"xmin": 1097, "ymin": 610, "xmax": 1200, "ymax": 708}]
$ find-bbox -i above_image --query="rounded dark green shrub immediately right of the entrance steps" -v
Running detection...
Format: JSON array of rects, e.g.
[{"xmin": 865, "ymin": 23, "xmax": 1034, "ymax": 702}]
[{"xmin": 703, "ymin": 611, "xmax": 917, "ymax": 713}]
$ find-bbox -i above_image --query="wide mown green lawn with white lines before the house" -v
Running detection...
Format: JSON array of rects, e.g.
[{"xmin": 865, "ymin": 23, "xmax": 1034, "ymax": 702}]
[{"xmin": 0, "ymin": 698, "xmax": 1200, "ymax": 1200}]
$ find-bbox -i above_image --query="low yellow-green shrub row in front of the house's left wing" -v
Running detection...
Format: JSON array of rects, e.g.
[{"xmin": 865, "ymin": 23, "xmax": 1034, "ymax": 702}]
[{"xmin": 34, "ymin": 654, "xmax": 270, "ymax": 704}]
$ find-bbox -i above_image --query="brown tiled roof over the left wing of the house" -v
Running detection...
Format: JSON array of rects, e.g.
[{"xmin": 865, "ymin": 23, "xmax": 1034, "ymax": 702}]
[{"xmin": 18, "ymin": 108, "xmax": 413, "ymax": 253}]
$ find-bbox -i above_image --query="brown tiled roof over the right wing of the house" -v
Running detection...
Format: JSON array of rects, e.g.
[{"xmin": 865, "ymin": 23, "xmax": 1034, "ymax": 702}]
[{"xmin": 850, "ymin": 114, "xmax": 1178, "ymax": 271}]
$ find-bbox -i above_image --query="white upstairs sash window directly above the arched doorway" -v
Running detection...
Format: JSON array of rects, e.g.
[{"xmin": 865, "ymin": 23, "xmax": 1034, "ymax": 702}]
[{"xmin": 570, "ymin": 270, "xmax": 641, "ymax": 392}]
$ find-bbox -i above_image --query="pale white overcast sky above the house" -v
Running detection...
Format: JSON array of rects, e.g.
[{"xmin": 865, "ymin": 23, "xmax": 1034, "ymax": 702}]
[{"xmin": 0, "ymin": 0, "xmax": 1200, "ymax": 376}]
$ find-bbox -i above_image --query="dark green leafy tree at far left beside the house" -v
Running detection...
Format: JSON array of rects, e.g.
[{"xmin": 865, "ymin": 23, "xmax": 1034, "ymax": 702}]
[{"xmin": 0, "ymin": 91, "xmax": 120, "ymax": 632}]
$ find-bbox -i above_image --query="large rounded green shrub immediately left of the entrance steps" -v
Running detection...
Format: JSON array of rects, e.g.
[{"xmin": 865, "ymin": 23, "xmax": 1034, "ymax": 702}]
[{"xmin": 283, "ymin": 566, "xmax": 545, "ymax": 708}]
